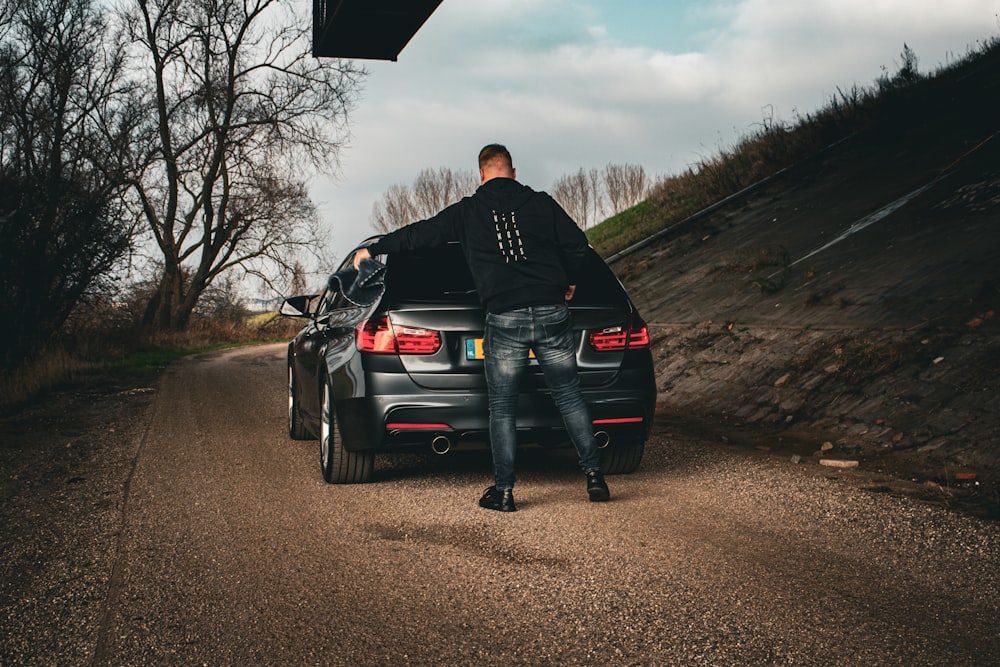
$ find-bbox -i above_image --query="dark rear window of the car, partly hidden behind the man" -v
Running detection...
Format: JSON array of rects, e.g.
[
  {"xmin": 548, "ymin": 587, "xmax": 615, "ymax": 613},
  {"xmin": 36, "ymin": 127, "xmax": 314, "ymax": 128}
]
[{"xmin": 386, "ymin": 243, "xmax": 625, "ymax": 306}]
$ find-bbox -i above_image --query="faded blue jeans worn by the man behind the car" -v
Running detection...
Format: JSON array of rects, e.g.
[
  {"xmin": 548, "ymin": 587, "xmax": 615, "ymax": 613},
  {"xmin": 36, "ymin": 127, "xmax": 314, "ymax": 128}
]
[{"xmin": 483, "ymin": 304, "xmax": 601, "ymax": 491}]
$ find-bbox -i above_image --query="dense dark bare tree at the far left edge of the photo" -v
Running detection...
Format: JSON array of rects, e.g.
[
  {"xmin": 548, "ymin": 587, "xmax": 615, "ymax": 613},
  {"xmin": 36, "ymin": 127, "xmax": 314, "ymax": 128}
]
[{"xmin": 0, "ymin": 0, "xmax": 131, "ymax": 366}]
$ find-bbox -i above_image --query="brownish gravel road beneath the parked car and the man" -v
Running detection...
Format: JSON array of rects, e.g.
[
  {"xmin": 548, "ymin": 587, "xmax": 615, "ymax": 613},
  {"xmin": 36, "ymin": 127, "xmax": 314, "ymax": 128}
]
[{"xmin": 0, "ymin": 345, "xmax": 1000, "ymax": 666}]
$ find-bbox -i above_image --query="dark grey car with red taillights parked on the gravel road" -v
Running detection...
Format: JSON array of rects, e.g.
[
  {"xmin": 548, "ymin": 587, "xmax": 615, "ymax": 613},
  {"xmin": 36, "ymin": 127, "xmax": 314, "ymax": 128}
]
[{"xmin": 281, "ymin": 239, "xmax": 656, "ymax": 483}]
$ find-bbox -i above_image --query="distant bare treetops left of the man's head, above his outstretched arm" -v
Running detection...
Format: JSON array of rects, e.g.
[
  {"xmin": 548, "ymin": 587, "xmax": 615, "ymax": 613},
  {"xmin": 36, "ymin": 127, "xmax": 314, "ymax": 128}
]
[{"xmin": 371, "ymin": 167, "xmax": 479, "ymax": 234}]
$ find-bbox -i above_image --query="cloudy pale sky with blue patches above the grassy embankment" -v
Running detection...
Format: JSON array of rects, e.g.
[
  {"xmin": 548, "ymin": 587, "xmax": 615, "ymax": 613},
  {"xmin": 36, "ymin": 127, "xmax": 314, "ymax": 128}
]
[{"xmin": 310, "ymin": 0, "xmax": 1000, "ymax": 262}]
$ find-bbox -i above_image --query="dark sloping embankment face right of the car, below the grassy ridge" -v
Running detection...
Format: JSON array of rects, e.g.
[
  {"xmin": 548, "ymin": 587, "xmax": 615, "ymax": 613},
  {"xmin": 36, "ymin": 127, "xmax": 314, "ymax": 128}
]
[{"xmin": 613, "ymin": 86, "xmax": 1000, "ymax": 516}]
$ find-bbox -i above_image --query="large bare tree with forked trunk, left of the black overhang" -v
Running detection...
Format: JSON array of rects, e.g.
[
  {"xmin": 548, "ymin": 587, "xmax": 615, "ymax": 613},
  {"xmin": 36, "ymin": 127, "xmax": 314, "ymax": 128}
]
[{"xmin": 122, "ymin": 0, "xmax": 364, "ymax": 329}]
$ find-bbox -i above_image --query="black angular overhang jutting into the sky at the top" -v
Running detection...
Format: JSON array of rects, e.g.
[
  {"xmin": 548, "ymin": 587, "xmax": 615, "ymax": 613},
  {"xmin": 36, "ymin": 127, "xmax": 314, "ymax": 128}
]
[{"xmin": 313, "ymin": 0, "xmax": 442, "ymax": 60}]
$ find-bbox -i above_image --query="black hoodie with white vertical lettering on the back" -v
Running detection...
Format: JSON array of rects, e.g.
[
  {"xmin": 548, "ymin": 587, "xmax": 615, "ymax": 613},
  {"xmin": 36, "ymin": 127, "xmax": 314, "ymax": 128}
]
[{"xmin": 368, "ymin": 178, "xmax": 588, "ymax": 313}]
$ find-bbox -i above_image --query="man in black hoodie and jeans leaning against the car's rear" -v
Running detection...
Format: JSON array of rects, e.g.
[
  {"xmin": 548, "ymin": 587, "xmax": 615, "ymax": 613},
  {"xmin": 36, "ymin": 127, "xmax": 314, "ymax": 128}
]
[{"xmin": 354, "ymin": 144, "xmax": 611, "ymax": 512}]
